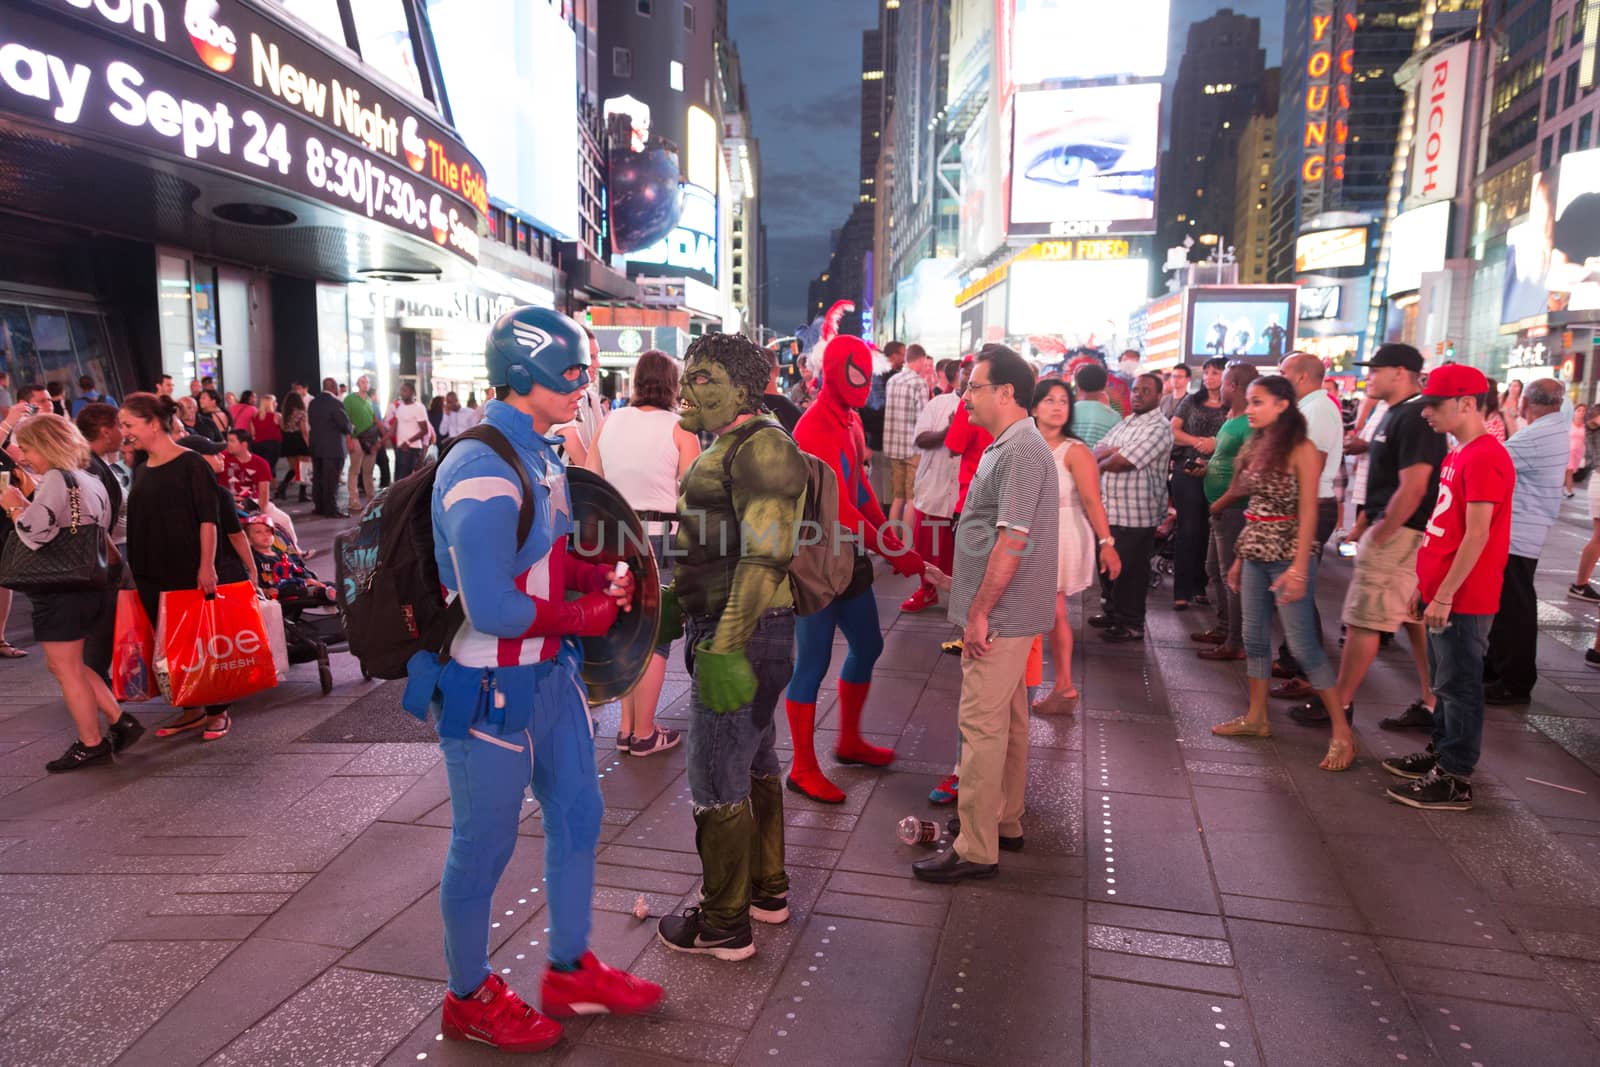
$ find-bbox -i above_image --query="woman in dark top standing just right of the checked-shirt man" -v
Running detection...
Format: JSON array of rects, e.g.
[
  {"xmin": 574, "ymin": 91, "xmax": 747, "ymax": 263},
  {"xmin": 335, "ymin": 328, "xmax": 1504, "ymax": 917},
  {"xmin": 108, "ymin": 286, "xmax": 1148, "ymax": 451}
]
[{"xmin": 1168, "ymin": 357, "xmax": 1227, "ymax": 611}]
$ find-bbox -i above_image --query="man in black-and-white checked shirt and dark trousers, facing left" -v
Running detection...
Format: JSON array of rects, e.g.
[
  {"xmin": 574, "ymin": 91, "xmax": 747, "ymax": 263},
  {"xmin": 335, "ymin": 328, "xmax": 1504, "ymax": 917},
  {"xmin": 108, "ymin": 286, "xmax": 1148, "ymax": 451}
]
[{"xmin": 1090, "ymin": 374, "xmax": 1173, "ymax": 641}]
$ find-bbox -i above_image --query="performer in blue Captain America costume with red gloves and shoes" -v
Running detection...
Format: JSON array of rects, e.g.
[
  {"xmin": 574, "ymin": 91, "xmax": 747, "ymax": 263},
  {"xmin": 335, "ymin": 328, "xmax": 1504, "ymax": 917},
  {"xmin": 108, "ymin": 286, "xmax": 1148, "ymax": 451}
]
[{"xmin": 405, "ymin": 307, "xmax": 661, "ymax": 1051}]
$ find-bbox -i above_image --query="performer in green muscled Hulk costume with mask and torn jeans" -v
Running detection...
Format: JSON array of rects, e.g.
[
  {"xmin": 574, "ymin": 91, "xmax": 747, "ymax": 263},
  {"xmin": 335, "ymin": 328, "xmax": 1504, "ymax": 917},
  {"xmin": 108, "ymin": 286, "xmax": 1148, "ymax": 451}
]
[{"xmin": 659, "ymin": 333, "xmax": 808, "ymax": 960}]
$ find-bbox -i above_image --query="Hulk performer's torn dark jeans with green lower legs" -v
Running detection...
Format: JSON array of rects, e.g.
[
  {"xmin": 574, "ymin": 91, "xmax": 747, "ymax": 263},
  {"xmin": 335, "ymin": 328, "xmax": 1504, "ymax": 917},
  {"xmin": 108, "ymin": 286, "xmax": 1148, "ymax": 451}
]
[{"xmin": 683, "ymin": 608, "xmax": 795, "ymax": 929}]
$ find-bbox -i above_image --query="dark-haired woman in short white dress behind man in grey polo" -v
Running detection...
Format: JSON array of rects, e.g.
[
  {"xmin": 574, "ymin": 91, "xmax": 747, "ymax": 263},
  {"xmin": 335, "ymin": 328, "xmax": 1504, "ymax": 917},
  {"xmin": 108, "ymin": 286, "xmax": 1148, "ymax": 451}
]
[{"xmin": 1034, "ymin": 378, "xmax": 1122, "ymax": 715}]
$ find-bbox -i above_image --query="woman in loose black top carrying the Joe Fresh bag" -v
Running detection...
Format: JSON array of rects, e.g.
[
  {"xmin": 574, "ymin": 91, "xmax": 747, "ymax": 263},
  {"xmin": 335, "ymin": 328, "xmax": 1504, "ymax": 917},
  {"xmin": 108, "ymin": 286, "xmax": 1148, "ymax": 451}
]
[{"xmin": 118, "ymin": 394, "xmax": 250, "ymax": 741}]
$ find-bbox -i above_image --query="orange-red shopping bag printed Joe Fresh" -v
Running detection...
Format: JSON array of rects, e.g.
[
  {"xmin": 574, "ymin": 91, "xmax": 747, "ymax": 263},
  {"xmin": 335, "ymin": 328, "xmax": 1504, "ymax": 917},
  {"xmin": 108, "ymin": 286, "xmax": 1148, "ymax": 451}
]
[{"xmin": 162, "ymin": 582, "xmax": 278, "ymax": 707}]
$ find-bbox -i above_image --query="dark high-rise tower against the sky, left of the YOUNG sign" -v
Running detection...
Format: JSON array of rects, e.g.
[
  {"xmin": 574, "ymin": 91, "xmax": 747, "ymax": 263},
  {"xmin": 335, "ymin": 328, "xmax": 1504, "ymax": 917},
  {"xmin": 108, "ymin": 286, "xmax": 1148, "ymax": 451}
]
[{"xmin": 1157, "ymin": 8, "xmax": 1277, "ymax": 259}]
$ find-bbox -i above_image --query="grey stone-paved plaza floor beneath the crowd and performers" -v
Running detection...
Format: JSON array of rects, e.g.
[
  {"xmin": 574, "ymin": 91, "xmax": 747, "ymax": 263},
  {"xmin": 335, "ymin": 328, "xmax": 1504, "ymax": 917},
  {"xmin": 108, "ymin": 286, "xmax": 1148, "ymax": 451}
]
[{"xmin": 0, "ymin": 501, "xmax": 1600, "ymax": 1067}]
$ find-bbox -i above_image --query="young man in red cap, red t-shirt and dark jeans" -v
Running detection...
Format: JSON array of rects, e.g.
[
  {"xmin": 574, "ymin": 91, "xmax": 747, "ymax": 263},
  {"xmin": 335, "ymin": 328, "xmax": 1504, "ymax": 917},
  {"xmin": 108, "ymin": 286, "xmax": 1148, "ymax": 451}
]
[{"xmin": 1384, "ymin": 363, "xmax": 1517, "ymax": 811}]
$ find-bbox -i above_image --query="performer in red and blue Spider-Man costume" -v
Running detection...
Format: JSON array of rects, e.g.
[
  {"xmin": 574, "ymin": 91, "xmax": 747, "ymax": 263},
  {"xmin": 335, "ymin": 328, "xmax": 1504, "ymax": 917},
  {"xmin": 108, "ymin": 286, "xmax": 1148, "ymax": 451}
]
[{"xmin": 787, "ymin": 313, "xmax": 922, "ymax": 805}]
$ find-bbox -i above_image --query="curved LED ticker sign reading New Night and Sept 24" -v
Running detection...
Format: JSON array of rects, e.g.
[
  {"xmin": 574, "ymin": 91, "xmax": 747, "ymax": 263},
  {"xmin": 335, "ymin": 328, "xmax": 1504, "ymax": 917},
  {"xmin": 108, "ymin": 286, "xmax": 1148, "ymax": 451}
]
[{"xmin": 0, "ymin": 0, "xmax": 488, "ymax": 262}]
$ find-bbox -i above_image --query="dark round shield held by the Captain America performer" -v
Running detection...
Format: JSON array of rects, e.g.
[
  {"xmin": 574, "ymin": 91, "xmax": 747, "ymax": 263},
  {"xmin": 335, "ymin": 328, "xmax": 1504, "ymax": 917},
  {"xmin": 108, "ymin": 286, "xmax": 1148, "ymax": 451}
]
[{"xmin": 566, "ymin": 467, "xmax": 661, "ymax": 707}]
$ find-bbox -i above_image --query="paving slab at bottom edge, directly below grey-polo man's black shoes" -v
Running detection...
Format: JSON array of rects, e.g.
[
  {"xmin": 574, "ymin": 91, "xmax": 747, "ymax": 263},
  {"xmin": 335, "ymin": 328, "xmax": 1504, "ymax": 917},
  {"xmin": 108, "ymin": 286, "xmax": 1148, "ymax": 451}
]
[{"xmin": 915, "ymin": 886, "xmax": 1083, "ymax": 1064}]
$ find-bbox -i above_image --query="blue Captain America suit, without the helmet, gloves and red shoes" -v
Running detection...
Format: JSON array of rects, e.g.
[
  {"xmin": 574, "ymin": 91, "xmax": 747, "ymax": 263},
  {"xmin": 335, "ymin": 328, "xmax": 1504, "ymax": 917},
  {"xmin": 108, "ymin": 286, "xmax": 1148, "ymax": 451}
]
[{"xmin": 403, "ymin": 400, "xmax": 603, "ymax": 997}]
